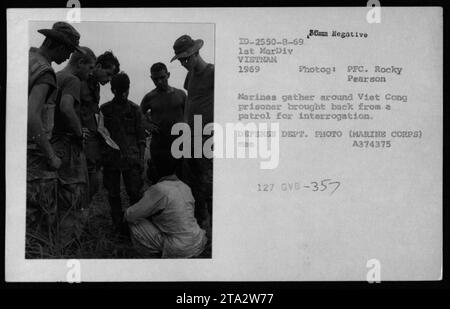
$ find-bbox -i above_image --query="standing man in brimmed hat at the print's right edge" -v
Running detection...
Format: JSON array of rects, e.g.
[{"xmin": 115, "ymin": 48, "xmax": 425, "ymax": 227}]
[{"xmin": 171, "ymin": 35, "xmax": 214, "ymax": 231}]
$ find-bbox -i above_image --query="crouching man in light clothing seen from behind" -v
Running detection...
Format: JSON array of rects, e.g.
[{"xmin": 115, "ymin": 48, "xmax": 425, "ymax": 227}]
[{"xmin": 125, "ymin": 155, "xmax": 207, "ymax": 258}]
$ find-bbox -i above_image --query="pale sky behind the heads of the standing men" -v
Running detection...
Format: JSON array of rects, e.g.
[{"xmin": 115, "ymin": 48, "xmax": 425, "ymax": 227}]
[{"xmin": 29, "ymin": 21, "xmax": 214, "ymax": 104}]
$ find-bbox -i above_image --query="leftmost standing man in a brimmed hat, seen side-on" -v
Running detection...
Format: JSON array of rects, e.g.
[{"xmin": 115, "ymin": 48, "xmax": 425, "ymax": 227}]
[{"xmin": 27, "ymin": 22, "xmax": 85, "ymax": 253}]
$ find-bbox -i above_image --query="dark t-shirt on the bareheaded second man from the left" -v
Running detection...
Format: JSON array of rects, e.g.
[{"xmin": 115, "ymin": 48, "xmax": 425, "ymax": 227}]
[{"xmin": 53, "ymin": 70, "xmax": 81, "ymax": 134}]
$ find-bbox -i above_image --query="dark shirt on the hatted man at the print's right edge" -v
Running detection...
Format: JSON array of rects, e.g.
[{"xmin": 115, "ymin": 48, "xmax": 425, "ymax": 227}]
[{"xmin": 184, "ymin": 64, "xmax": 214, "ymax": 131}]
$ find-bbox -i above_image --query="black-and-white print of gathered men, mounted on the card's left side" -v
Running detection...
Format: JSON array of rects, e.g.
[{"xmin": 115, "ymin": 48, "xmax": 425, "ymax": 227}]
[{"xmin": 25, "ymin": 21, "xmax": 214, "ymax": 259}]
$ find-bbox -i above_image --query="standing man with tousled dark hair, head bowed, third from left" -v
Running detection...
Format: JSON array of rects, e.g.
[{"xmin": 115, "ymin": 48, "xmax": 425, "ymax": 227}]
[{"xmin": 80, "ymin": 51, "xmax": 120, "ymax": 201}]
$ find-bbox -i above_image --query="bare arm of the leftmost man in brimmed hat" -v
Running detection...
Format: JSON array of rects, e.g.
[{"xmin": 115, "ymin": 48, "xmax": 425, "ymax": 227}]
[{"xmin": 28, "ymin": 84, "xmax": 56, "ymax": 160}]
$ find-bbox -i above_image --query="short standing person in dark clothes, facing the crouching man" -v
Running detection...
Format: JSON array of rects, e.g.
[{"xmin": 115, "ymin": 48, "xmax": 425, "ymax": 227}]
[{"xmin": 100, "ymin": 73, "xmax": 145, "ymax": 233}]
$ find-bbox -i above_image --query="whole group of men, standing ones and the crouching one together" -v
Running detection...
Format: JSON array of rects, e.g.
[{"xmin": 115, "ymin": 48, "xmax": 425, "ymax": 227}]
[{"xmin": 26, "ymin": 22, "xmax": 214, "ymax": 257}]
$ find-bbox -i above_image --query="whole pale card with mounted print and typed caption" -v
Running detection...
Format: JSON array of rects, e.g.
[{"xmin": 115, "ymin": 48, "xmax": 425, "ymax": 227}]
[{"xmin": 5, "ymin": 5, "xmax": 445, "ymax": 284}]
